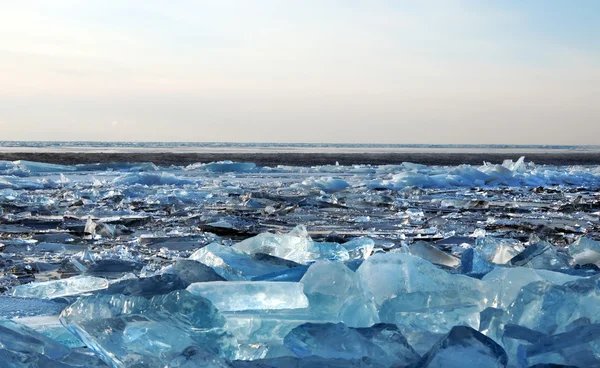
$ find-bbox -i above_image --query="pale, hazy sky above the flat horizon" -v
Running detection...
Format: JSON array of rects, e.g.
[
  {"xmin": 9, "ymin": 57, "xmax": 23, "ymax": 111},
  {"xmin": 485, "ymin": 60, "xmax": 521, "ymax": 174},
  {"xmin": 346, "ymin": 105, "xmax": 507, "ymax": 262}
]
[{"xmin": 0, "ymin": 0, "xmax": 600, "ymax": 145}]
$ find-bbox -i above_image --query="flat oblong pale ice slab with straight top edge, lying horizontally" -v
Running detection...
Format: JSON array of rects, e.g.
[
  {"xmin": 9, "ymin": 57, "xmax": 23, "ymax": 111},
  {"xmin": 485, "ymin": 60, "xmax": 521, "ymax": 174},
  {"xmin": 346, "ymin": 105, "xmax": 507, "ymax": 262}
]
[{"xmin": 187, "ymin": 281, "xmax": 308, "ymax": 311}]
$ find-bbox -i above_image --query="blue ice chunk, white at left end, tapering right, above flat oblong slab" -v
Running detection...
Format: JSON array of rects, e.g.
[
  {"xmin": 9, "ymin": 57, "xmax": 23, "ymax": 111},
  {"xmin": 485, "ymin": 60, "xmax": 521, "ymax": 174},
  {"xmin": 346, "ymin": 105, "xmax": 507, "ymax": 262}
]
[{"xmin": 189, "ymin": 243, "xmax": 289, "ymax": 281}]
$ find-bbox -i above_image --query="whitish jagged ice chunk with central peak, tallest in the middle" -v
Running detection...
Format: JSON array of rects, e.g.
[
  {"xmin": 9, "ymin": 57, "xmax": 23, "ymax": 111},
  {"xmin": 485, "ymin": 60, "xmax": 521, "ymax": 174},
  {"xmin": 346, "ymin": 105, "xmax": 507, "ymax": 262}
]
[{"xmin": 233, "ymin": 225, "xmax": 350, "ymax": 264}]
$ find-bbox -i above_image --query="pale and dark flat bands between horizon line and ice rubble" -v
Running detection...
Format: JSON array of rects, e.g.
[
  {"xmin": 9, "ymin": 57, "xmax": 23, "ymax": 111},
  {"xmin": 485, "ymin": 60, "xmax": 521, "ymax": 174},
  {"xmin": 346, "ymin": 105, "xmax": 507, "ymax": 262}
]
[{"xmin": 0, "ymin": 147, "xmax": 600, "ymax": 166}]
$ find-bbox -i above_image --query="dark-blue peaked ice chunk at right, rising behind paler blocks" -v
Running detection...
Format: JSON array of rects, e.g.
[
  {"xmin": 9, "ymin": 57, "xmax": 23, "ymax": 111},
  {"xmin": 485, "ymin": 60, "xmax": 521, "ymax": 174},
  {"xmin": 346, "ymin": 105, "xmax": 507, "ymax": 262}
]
[{"xmin": 510, "ymin": 241, "xmax": 569, "ymax": 270}]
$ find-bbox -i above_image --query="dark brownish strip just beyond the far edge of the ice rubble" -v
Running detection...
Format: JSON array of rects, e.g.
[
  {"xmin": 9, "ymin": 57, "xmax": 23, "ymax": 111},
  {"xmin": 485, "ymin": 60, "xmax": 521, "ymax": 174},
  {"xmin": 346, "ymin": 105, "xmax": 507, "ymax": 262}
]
[{"xmin": 0, "ymin": 152, "xmax": 600, "ymax": 166}]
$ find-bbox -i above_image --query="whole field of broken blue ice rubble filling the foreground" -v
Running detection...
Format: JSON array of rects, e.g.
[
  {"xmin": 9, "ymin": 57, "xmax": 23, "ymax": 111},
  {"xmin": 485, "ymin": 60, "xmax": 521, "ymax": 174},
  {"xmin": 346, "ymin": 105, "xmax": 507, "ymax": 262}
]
[{"xmin": 0, "ymin": 159, "xmax": 600, "ymax": 368}]
